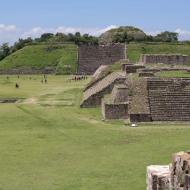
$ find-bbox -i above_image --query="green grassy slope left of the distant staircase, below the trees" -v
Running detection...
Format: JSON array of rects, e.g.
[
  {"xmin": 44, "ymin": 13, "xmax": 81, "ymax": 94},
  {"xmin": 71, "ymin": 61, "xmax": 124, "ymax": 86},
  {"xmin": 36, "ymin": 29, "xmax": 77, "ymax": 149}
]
[{"xmin": 0, "ymin": 44, "xmax": 77, "ymax": 74}]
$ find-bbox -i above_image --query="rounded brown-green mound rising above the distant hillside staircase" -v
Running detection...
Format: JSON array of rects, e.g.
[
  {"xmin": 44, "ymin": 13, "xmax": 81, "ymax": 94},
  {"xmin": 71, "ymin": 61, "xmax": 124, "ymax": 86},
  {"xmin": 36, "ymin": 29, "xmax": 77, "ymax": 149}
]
[{"xmin": 99, "ymin": 26, "xmax": 146, "ymax": 44}]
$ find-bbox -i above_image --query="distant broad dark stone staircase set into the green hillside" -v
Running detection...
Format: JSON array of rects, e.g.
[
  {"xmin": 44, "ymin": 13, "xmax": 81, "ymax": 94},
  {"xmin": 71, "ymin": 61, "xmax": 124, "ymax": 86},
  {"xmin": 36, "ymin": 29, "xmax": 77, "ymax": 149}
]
[{"xmin": 77, "ymin": 44, "xmax": 126, "ymax": 74}]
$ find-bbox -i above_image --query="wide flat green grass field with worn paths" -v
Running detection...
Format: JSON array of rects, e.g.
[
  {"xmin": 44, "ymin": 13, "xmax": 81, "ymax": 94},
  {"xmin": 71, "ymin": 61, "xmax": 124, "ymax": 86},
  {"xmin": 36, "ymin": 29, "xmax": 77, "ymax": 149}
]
[{"xmin": 0, "ymin": 76, "xmax": 190, "ymax": 190}]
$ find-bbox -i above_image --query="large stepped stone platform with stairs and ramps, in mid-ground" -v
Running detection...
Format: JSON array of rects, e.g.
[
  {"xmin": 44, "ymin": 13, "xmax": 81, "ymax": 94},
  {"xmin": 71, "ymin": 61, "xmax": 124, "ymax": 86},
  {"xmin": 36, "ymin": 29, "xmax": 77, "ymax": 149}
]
[{"xmin": 81, "ymin": 58, "xmax": 190, "ymax": 122}]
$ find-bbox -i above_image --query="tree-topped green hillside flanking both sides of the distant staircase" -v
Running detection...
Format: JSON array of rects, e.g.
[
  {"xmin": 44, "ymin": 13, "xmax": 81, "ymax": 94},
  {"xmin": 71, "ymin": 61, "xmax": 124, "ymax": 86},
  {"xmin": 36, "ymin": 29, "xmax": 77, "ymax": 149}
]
[{"xmin": 0, "ymin": 26, "xmax": 190, "ymax": 74}]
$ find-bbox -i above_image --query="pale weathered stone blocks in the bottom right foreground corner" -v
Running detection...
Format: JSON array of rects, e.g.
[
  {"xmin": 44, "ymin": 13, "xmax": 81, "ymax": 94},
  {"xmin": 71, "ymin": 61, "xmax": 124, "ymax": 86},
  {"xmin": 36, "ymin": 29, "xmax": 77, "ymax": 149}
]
[{"xmin": 147, "ymin": 152, "xmax": 190, "ymax": 190}]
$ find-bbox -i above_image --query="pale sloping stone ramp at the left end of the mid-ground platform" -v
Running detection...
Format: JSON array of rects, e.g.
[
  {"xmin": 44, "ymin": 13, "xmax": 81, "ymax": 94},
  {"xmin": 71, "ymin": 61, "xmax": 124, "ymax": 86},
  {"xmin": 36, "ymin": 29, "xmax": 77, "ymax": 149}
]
[{"xmin": 81, "ymin": 72, "xmax": 126, "ymax": 108}]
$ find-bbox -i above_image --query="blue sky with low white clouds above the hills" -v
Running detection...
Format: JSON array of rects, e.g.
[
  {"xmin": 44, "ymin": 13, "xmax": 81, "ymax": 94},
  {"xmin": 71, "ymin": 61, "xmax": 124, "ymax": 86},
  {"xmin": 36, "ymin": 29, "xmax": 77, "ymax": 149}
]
[{"xmin": 0, "ymin": 0, "xmax": 190, "ymax": 43}]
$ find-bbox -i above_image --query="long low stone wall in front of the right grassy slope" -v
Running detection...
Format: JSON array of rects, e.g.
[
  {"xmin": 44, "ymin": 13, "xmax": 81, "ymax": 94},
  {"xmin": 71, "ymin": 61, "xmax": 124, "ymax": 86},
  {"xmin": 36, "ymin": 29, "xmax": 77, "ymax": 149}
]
[{"xmin": 139, "ymin": 54, "xmax": 190, "ymax": 64}]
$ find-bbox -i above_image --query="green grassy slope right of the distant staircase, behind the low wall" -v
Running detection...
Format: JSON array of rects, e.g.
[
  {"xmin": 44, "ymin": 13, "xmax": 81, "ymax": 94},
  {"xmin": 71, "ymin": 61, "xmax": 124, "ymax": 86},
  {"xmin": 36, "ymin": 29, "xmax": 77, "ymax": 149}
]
[{"xmin": 127, "ymin": 43, "xmax": 190, "ymax": 62}]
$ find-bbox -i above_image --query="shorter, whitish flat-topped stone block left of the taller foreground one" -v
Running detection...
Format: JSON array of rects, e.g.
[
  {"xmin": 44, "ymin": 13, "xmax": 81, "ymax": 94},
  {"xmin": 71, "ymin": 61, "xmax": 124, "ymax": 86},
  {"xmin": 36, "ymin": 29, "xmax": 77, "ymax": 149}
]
[{"xmin": 147, "ymin": 166, "xmax": 171, "ymax": 190}]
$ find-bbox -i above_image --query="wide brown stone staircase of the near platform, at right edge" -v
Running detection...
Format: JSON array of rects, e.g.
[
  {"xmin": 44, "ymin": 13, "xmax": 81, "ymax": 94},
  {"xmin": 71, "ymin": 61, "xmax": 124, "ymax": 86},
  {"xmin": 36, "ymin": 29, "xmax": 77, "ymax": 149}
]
[{"xmin": 147, "ymin": 78, "xmax": 190, "ymax": 121}]
